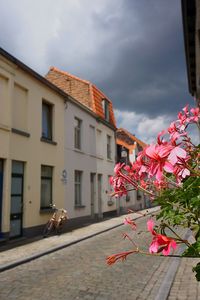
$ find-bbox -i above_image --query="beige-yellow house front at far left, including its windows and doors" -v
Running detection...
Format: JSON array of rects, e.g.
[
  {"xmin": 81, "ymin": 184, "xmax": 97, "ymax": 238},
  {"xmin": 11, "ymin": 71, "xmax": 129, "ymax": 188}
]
[{"xmin": 0, "ymin": 48, "xmax": 67, "ymax": 240}]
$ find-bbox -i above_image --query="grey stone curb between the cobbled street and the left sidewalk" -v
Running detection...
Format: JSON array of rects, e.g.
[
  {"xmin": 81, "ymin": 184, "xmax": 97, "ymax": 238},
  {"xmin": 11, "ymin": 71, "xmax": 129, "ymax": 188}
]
[{"xmin": 0, "ymin": 207, "xmax": 159, "ymax": 273}]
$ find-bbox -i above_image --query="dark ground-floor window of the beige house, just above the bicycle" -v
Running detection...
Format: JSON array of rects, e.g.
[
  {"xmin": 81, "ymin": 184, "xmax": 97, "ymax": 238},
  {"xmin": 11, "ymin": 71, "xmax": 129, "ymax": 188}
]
[{"xmin": 40, "ymin": 166, "xmax": 53, "ymax": 209}]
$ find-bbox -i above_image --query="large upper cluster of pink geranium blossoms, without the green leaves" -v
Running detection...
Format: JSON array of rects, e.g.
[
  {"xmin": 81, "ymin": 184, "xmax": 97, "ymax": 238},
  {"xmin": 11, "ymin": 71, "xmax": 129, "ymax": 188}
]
[{"xmin": 111, "ymin": 105, "xmax": 200, "ymax": 199}]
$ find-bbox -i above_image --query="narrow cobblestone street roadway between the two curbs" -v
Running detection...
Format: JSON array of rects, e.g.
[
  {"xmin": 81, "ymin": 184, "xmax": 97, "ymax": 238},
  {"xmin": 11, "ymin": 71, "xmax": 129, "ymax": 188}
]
[{"xmin": 0, "ymin": 218, "xmax": 170, "ymax": 300}]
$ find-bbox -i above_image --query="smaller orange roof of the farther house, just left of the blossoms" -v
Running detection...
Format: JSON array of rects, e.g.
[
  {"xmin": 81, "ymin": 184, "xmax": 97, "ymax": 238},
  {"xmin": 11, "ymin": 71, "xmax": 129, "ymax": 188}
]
[{"xmin": 116, "ymin": 128, "xmax": 147, "ymax": 150}]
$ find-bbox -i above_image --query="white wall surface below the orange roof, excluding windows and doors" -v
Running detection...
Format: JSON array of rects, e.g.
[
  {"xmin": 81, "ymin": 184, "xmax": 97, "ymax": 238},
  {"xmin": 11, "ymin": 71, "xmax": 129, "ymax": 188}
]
[{"xmin": 64, "ymin": 102, "xmax": 116, "ymax": 218}]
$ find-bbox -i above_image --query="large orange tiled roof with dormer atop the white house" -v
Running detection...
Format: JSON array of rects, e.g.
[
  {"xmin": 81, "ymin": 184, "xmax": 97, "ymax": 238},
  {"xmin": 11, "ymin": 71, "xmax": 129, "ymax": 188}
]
[{"xmin": 46, "ymin": 67, "xmax": 116, "ymax": 128}]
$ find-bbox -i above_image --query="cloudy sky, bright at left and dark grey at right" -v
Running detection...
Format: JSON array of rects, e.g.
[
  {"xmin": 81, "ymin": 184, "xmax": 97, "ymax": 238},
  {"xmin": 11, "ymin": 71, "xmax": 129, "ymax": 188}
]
[{"xmin": 0, "ymin": 0, "xmax": 197, "ymax": 142}]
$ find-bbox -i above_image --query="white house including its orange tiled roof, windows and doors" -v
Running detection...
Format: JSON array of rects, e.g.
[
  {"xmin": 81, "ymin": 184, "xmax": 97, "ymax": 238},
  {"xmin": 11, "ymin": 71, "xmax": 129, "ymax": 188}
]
[{"xmin": 46, "ymin": 67, "xmax": 118, "ymax": 219}]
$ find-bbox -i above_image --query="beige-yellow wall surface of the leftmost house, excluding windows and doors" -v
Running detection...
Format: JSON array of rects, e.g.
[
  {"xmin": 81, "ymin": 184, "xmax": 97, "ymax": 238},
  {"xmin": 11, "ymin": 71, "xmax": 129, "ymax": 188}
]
[{"xmin": 0, "ymin": 56, "xmax": 64, "ymax": 237}]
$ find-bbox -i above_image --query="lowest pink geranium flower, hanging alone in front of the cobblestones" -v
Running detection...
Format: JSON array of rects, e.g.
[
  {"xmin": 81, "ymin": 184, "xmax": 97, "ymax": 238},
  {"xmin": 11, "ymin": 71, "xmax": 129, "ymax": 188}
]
[{"xmin": 147, "ymin": 219, "xmax": 177, "ymax": 256}]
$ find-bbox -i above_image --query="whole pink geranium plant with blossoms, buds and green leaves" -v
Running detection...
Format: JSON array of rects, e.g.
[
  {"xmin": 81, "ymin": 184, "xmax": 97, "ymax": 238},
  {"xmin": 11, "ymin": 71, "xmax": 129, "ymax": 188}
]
[{"xmin": 107, "ymin": 105, "xmax": 200, "ymax": 280}]
